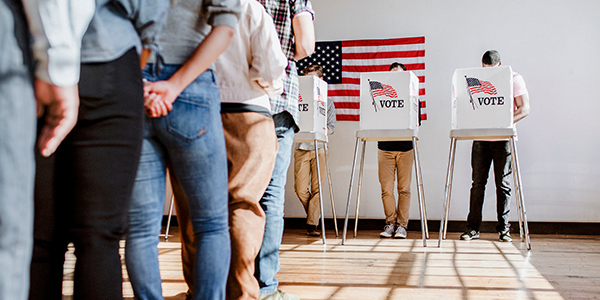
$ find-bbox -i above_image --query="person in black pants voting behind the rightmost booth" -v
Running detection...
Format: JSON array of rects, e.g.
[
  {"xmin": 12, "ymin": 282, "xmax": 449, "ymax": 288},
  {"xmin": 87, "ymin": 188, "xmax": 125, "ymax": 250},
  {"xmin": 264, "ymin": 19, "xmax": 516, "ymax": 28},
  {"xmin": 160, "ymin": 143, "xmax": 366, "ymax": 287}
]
[{"xmin": 460, "ymin": 50, "xmax": 529, "ymax": 242}]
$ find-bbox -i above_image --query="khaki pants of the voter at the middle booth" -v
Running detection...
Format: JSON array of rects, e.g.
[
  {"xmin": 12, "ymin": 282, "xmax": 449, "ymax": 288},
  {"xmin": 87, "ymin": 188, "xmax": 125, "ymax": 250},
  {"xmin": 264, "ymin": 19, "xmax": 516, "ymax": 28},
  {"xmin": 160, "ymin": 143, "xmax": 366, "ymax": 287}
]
[{"xmin": 378, "ymin": 150, "xmax": 414, "ymax": 228}]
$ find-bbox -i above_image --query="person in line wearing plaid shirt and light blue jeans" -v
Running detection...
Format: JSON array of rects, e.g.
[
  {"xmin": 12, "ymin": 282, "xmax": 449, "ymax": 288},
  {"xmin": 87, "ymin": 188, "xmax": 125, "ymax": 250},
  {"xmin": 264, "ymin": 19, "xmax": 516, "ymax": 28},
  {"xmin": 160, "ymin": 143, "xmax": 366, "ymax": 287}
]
[{"xmin": 254, "ymin": 0, "xmax": 315, "ymax": 299}]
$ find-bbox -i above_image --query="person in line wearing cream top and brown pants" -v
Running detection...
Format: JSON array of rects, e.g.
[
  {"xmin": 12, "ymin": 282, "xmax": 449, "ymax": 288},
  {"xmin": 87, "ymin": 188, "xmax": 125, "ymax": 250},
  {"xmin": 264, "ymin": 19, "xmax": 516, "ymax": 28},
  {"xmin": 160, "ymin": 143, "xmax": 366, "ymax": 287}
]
[{"xmin": 215, "ymin": 0, "xmax": 287, "ymax": 299}]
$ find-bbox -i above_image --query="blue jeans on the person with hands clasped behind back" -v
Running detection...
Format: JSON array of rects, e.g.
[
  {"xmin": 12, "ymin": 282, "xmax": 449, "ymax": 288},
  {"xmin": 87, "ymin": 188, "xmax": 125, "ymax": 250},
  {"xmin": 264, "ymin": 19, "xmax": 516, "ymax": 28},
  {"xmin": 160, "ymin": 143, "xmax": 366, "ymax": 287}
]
[{"xmin": 125, "ymin": 65, "xmax": 231, "ymax": 299}]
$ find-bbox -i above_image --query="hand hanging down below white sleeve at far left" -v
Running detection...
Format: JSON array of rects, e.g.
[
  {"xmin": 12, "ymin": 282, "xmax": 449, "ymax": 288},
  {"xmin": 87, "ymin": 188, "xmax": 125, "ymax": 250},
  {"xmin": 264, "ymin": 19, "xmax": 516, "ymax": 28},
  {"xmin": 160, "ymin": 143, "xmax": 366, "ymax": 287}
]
[{"xmin": 34, "ymin": 79, "xmax": 79, "ymax": 157}]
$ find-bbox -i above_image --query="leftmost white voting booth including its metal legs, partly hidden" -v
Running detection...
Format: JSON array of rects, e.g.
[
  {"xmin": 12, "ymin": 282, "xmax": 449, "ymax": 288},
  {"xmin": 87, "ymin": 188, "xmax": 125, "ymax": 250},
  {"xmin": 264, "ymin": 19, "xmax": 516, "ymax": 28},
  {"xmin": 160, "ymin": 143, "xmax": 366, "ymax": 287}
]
[{"xmin": 294, "ymin": 76, "xmax": 338, "ymax": 244}]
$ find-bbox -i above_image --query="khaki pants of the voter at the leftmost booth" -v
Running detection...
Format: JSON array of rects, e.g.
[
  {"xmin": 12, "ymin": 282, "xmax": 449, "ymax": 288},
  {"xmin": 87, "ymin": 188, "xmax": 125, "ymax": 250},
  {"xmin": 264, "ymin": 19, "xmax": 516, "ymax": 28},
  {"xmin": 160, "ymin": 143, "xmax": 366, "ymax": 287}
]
[{"xmin": 294, "ymin": 148, "xmax": 327, "ymax": 226}]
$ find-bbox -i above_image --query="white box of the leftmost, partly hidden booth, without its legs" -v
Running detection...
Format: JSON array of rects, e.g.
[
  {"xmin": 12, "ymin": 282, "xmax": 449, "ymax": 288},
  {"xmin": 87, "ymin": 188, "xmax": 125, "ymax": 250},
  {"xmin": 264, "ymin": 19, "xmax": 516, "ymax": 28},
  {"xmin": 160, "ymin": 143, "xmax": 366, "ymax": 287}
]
[{"xmin": 298, "ymin": 76, "xmax": 327, "ymax": 135}]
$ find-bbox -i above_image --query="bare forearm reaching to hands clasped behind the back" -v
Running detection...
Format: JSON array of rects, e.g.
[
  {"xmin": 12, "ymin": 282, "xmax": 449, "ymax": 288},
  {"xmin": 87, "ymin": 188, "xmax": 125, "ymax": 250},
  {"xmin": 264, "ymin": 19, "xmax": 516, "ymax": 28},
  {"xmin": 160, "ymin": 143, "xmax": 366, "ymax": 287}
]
[{"xmin": 144, "ymin": 25, "xmax": 234, "ymax": 118}]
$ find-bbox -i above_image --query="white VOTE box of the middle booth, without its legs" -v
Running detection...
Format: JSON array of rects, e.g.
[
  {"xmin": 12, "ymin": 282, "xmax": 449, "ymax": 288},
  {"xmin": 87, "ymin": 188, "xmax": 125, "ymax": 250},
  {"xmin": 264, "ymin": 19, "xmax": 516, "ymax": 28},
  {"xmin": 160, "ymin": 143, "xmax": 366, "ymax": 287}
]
[{"xmin": 358, "ymin": 72, "xmax": 419, "ymax": 130}]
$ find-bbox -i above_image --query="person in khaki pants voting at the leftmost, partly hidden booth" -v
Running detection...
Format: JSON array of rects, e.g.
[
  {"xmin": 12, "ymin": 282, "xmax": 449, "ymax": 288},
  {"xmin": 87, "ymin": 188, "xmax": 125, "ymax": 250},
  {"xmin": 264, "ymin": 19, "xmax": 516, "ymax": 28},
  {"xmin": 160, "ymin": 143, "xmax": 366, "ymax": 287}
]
[{"xmin": 294, "ymin": 65, "xmax": 337, "ymax": 236}]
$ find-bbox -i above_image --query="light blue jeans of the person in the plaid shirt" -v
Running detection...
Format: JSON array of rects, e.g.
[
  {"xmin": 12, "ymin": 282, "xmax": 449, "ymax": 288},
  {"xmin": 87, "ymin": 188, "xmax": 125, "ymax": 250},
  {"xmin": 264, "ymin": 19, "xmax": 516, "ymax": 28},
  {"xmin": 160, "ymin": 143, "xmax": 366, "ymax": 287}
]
[{"xmin": 254, "ymin": 112, "xmax": 295, "ymax": 295}]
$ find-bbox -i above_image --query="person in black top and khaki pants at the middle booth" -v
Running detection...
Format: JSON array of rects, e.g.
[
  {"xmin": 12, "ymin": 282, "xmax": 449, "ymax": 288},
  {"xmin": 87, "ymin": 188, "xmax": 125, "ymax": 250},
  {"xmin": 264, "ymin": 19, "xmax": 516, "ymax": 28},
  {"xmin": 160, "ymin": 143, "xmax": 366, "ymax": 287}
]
[{"xmin": 377, "ymin": 62, "xmax": 421, "ymax": 239}]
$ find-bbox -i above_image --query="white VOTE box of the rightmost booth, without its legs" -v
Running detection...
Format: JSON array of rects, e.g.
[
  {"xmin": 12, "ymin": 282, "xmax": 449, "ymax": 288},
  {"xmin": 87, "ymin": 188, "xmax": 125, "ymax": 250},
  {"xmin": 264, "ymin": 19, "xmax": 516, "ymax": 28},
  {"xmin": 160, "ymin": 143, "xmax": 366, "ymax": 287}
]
[{"xmin": 452, "ymin": 67, "xmax": 514, "ymax": 129}]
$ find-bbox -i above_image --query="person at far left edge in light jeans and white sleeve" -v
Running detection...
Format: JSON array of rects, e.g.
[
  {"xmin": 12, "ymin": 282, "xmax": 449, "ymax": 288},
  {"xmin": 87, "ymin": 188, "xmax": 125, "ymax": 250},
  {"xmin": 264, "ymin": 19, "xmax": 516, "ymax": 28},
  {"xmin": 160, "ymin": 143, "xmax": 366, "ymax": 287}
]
[{"xmin": 0, "ymin": 0, "xmax": 94, "ymax": 300}]
